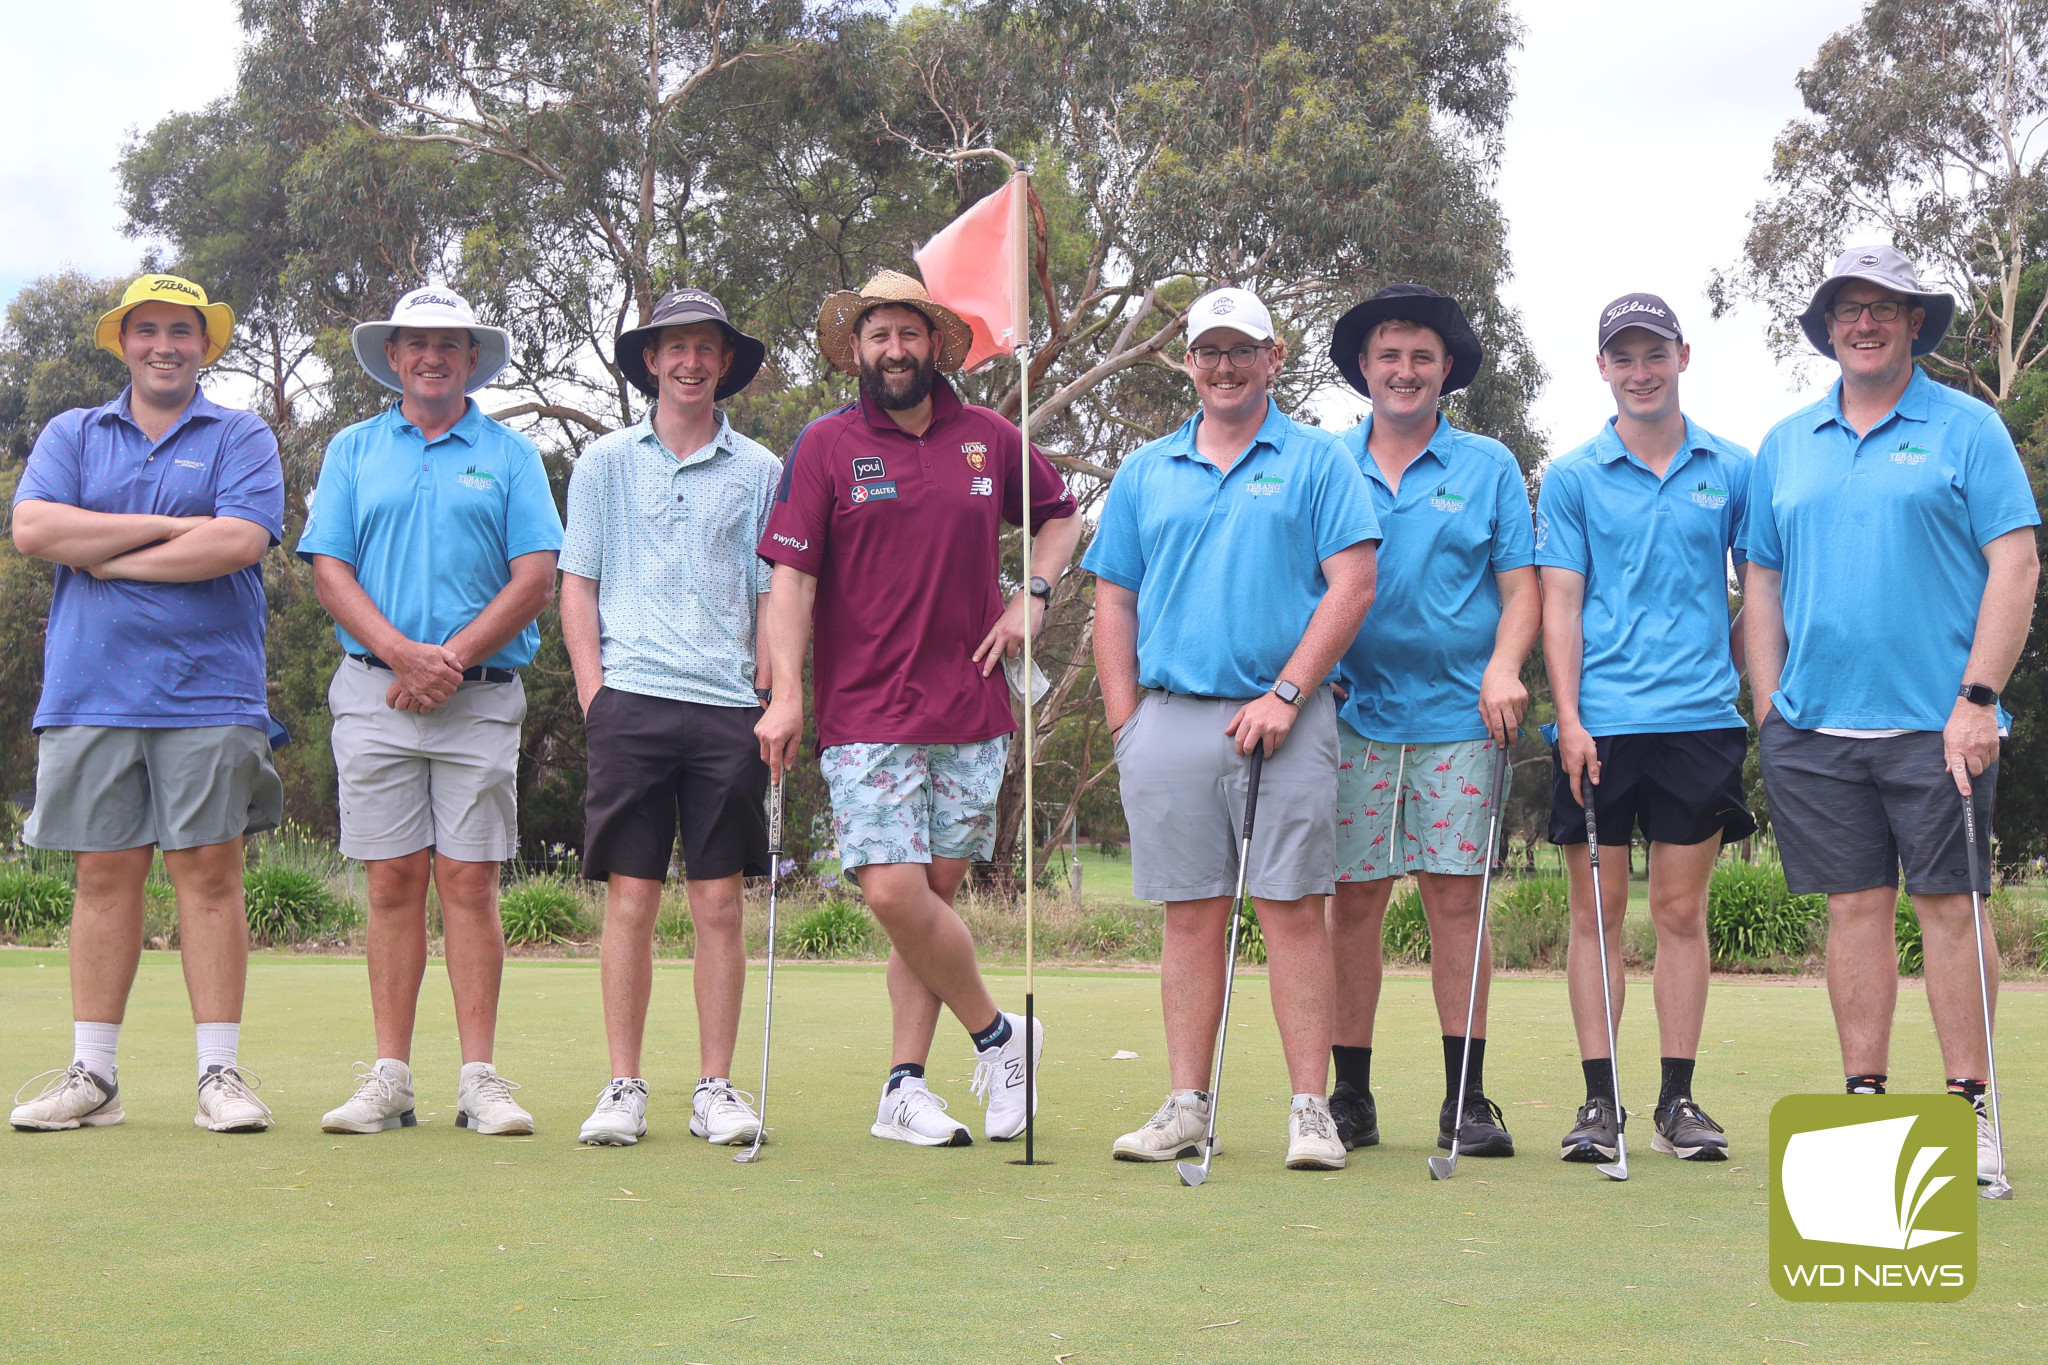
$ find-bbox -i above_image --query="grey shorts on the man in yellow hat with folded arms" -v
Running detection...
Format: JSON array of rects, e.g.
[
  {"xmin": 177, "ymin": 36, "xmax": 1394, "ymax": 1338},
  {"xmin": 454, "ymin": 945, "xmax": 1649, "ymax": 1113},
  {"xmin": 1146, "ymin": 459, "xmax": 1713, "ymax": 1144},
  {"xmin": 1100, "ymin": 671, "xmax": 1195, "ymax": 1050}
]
[{"xmin": 23, "ymin": 724, "xmax": 285, "ymax": 853}]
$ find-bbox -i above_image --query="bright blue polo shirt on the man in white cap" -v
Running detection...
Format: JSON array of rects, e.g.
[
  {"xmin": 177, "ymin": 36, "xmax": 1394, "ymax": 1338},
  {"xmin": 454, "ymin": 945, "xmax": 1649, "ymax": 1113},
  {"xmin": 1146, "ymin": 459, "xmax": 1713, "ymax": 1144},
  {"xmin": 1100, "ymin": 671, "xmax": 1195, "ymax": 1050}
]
[{"xmin": 1081, "ymin": 399, "xmax": 1380, "ymax": 698}]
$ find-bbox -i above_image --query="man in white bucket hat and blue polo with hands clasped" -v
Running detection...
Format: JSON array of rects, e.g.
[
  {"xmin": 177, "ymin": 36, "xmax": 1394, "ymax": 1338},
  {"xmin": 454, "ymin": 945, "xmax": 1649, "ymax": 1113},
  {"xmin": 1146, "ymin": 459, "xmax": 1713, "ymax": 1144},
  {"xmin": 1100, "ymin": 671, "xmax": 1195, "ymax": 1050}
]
[{"xmin": 299, "ymin": 287, "xmax": 561, "ymax": 1134}]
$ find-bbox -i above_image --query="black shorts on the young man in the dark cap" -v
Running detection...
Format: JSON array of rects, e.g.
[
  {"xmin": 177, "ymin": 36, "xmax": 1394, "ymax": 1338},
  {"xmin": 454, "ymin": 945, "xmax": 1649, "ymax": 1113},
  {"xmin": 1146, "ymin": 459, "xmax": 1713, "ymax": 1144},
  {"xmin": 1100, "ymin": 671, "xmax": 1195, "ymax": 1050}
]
[{"xmin": 1550, "ymin": 724, "xmax": 1757, "ymax": 845}]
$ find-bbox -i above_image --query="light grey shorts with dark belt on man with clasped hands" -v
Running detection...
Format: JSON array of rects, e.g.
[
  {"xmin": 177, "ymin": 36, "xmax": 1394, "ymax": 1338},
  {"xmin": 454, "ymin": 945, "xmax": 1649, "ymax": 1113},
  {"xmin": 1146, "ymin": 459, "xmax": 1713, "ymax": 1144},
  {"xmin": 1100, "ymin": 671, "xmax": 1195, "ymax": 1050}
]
[{"xmin": 328, "ymin": 659, "xmax": 526, "ymax": 862}]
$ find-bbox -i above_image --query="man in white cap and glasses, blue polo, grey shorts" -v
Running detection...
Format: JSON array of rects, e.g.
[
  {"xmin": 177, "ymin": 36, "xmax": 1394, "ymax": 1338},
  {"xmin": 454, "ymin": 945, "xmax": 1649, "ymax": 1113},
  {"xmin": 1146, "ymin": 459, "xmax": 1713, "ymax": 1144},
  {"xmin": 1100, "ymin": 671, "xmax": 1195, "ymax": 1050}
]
[{"xmin": 1083, "ymin": 289, "xmax": 1380, "ymax": 1171}]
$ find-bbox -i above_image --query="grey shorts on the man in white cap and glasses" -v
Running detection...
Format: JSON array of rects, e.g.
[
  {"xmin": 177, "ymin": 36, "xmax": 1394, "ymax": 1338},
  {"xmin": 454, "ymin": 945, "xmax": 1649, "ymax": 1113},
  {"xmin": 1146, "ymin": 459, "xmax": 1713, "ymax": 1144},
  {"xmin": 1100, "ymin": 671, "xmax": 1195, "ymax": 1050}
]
[{"xmin": 1116, "ymin": 688, "xmax": 1337, "ymax": 900}]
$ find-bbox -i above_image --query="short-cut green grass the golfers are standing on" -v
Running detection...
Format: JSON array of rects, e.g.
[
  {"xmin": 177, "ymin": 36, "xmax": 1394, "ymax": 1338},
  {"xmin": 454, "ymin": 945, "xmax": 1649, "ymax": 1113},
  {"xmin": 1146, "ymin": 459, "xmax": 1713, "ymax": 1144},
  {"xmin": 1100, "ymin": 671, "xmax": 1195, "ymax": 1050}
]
[{"xmin": 0, "ymin": 950, "xmax": 2048, "ymax": 1365}]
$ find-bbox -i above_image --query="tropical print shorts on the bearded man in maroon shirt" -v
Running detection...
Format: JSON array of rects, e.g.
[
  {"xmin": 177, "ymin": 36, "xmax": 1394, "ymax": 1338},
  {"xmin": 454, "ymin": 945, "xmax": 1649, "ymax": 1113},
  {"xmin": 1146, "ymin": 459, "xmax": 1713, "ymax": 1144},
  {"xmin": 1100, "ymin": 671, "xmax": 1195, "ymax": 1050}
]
[{"xmin": 821, "ymin": 735, "xmax": 1010, "ymax": 872}]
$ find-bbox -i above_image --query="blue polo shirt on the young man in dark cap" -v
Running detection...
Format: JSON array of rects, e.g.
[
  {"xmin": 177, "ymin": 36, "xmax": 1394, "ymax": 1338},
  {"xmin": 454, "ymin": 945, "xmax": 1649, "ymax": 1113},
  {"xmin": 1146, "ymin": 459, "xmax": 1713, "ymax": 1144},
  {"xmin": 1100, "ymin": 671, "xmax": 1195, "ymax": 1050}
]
[{"xmin": 1536, "ymin": 417, "xmax": 1755, "ymax": 735}]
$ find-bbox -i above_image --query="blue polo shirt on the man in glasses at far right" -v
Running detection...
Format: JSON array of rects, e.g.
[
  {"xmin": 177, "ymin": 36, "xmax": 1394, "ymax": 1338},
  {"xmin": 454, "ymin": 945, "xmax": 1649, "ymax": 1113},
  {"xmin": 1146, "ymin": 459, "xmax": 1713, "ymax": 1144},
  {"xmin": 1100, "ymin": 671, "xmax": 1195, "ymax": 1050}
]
[{"xmin": 1743, "ymin": 368, "xmax": 2042, "ymax": 731}]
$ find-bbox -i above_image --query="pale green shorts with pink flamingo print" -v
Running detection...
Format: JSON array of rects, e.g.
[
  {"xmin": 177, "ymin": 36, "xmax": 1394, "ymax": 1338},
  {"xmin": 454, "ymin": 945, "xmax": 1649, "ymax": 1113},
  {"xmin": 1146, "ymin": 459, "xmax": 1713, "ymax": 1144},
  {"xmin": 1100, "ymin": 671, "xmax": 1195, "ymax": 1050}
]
[{"xmin": 1337, "ymin": 720, "xmax": 1493, "ymax": 882}]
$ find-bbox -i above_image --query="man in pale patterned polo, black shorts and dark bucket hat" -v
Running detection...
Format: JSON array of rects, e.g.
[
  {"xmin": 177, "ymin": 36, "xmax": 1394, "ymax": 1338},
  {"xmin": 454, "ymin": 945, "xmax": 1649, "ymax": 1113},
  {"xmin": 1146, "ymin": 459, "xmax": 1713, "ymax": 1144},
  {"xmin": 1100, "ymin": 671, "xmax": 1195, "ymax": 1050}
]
[{"xmin": 561, "ymin": 289, "xmax": 782, "ymax": 1146}]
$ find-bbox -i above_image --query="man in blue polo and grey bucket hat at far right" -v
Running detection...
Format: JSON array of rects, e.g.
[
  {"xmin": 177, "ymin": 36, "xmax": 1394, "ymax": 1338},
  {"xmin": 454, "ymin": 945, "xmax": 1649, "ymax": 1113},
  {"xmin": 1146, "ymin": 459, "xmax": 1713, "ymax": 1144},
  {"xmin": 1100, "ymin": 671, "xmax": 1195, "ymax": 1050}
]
[{"xmin": 1743, "ymin": 246, "xmax": 2040, "ymax": 1177}]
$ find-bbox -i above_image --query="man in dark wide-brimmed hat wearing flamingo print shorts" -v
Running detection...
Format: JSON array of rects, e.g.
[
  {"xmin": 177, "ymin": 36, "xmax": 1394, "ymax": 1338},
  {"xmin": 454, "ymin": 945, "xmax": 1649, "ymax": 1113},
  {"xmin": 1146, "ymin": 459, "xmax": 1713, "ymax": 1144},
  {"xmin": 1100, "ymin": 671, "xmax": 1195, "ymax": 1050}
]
[{"xmin": 1329, "ymin": 284, "xmax": 1542, "ymax": 1156}]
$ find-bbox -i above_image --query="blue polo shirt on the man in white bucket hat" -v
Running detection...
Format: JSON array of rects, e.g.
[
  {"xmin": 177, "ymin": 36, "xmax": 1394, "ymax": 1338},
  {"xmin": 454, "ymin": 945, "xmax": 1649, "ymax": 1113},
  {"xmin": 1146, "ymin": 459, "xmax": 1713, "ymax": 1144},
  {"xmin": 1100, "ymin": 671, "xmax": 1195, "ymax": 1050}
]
[{"xmin": 297, "ymin": 399, "xmax": 561, "ymax": 669}]
